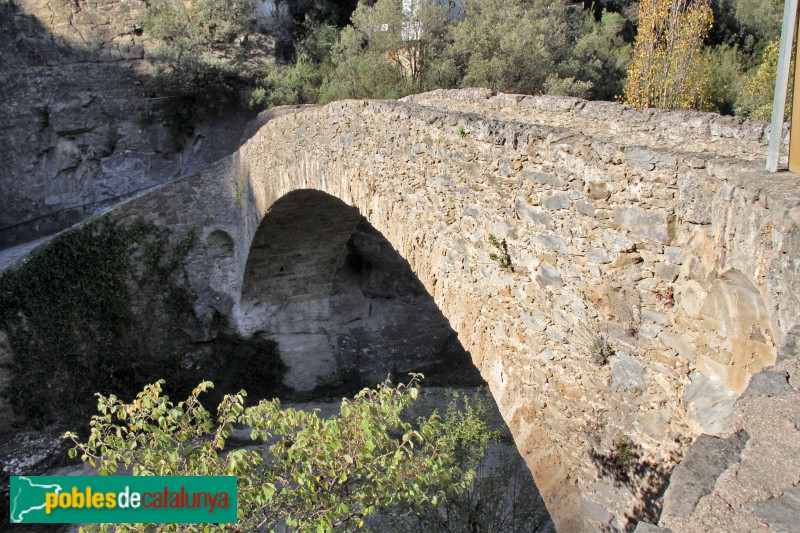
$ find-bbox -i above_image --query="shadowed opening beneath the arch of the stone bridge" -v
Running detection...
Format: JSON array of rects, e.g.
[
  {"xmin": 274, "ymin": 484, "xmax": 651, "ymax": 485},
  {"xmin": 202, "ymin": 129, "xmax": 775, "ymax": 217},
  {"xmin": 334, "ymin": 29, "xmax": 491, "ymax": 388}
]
[{"xmin": 236, "ymin": 189, "xmax": 479, "ymax": 391}]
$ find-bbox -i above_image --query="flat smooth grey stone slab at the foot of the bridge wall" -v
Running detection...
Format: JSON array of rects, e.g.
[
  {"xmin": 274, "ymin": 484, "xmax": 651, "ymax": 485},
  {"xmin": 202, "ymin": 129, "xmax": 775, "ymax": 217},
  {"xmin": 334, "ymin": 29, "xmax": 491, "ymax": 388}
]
[{"xmin": 664, "ymin": 431, "xmax": 750, "ymax": 517}]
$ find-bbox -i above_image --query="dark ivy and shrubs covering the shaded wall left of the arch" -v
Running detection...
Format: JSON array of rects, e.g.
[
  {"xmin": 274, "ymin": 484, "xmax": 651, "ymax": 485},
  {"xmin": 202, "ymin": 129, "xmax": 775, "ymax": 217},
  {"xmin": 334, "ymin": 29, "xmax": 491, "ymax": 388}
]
[{"xmin": 0, "ymin": 218, "xmax": 285, "ymax": 425}]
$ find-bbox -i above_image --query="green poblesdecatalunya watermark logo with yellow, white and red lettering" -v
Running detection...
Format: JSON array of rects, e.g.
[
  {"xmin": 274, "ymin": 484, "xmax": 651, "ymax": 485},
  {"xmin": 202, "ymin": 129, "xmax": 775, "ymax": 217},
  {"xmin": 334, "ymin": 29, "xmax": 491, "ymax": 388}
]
[{"xmin": 9, "ymin": 476, "xmax": 236, "ymax": 524}]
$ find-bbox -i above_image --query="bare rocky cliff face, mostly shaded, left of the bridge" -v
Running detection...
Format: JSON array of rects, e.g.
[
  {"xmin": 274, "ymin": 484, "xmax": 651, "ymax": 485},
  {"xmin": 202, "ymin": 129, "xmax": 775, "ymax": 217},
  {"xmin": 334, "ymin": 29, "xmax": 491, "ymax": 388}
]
[{"xmin": 0, "ymin": 0, "xmax": 255, "ymax": 248}]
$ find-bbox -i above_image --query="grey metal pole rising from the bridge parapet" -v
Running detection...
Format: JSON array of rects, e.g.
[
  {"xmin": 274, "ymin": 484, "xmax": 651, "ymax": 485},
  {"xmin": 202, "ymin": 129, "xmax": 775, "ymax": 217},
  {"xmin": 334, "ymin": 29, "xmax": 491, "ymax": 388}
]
[{"xmin": 767, "ymin": 0, "xmax": 800, "ymax": 172}]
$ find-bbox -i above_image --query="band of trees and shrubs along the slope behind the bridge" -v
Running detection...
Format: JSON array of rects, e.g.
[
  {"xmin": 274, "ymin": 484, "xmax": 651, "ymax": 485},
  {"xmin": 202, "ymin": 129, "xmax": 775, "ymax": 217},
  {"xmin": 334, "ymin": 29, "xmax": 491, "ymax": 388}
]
[{"xmin": 147, "ymin": 0, "xmax": 782, "ymax": 118}]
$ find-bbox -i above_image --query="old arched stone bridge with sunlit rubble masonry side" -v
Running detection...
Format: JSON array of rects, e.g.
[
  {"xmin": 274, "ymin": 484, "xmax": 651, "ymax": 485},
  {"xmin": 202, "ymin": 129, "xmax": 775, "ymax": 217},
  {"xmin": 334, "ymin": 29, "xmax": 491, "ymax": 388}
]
[{"xmin": 4, "ymin": 89, "xmax": 800, "ymax": 531}]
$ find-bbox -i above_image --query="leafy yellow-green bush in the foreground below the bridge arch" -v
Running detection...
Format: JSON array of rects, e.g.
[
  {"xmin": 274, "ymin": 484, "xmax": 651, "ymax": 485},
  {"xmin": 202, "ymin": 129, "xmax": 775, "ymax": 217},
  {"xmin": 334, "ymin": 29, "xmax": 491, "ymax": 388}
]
[{"xmin": 65, "ymin": 376, "xmax": 490, "ymax": 531}]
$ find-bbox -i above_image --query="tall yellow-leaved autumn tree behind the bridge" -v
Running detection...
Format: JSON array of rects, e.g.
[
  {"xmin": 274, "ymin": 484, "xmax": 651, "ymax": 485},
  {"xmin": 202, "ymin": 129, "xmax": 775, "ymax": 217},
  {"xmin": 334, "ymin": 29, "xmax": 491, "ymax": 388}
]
[{"xmin": 624, "ymin": 0, "xmax": 713, "ymax": 109}]
